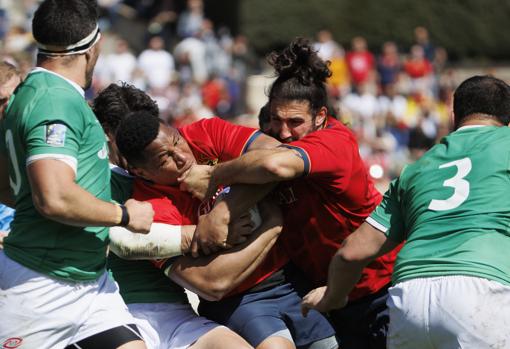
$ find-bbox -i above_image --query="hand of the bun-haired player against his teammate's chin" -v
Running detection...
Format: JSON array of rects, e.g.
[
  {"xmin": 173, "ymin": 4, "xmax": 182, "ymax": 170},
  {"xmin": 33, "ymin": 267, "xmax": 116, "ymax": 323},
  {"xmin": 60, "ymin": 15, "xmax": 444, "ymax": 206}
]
[{"xmin": 178, "ymin": 164, "xmax": 216, "ymax": 200}]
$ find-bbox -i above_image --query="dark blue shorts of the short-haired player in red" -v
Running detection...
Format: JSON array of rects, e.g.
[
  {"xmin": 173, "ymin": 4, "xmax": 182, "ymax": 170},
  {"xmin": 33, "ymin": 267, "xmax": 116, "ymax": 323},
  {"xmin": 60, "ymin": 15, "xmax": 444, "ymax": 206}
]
[{"xmin": 198, "ymin": 283, "xmax": 335, "ymax": 347}]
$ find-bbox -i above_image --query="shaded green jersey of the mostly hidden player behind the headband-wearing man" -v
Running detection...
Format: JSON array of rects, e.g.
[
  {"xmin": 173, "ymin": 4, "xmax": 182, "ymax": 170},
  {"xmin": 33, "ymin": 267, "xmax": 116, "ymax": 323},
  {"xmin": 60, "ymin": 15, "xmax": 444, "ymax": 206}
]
[{"xmin": 108, "ymin": 166, "xmax": 188, "ymax": 304}]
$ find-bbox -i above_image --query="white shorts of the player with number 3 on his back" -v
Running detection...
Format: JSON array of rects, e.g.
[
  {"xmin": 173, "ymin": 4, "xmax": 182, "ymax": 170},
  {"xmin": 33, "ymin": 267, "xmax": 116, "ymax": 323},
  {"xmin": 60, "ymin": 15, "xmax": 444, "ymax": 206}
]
[{"xmin": 387, "ymin": 276, "xmax": 510, "ymax": 349}]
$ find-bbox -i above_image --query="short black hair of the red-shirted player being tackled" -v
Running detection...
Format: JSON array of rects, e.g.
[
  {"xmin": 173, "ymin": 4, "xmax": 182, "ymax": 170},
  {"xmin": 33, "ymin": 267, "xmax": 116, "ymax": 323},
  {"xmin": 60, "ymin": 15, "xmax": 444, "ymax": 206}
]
[{"xmin": 115, "ymin": 110, "xmax": 160, "ymax": 166}]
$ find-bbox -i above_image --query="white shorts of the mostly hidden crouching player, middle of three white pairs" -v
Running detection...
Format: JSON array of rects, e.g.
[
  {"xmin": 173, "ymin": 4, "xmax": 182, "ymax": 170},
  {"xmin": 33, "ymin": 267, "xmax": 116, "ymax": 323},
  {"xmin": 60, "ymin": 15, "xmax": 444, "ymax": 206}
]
[{"xmin": 128, "ymin": 303, "xmax": 219, "ymax": 349}]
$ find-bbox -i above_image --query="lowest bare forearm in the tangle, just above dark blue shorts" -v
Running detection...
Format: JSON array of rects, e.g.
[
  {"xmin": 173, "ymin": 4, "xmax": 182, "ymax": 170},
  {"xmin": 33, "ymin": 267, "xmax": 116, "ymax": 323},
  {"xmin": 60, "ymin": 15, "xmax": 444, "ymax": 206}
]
[{"xmin": 169, "ymin": 215, "xmax": 282, "ymax": 300}]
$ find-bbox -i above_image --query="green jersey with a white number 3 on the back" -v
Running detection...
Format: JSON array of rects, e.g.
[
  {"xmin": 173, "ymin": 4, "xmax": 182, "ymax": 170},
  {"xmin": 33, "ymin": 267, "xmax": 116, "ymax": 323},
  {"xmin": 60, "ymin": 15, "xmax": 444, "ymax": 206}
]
[{"xmin": 367, "ymin": 126, "xmax": 510, "ymax": 285}]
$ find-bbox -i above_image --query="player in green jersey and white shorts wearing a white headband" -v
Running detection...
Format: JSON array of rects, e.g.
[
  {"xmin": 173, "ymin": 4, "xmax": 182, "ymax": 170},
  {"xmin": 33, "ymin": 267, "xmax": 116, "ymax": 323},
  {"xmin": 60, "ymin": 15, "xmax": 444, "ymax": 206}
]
[{"xmin": 0, "ymin": 0, "xmax": 153, "ymax": 349}]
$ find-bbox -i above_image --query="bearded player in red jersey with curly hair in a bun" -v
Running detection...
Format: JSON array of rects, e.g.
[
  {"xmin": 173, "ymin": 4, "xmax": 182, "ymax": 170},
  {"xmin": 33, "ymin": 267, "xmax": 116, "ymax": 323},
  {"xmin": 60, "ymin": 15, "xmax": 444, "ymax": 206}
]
[{"xmin": 182, "ymin": 39, "xmax": 396, "ymax": 348}]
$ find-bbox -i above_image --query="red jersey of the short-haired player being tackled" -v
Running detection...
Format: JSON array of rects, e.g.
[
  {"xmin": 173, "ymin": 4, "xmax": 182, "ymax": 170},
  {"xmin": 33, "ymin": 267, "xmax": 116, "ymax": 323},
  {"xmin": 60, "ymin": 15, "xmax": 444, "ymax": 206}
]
[{"xmin": 133, "ymin": 118, "xmax": 288, "ymax": 296}]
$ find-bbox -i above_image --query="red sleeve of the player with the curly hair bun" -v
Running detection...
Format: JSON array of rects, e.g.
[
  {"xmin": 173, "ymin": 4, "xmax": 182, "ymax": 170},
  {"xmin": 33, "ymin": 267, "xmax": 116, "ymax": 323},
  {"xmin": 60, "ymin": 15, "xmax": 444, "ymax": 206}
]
[{"xmin": 285, "ymin": 119, "xmax": 361, "ymax": 190}]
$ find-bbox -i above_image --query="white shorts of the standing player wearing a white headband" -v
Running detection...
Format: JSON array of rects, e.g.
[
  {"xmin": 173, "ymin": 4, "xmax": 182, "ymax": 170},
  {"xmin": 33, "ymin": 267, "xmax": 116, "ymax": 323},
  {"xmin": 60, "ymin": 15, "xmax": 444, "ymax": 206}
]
[{"xmin": 0, "ymin": 251, "xmax": 139, "ymax": 349}]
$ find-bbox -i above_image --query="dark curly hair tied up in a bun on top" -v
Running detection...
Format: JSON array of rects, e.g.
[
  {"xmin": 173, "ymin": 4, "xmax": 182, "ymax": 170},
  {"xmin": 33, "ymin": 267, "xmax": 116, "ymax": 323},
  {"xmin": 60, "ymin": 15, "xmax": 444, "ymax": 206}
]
[{"xmin": 267, "ymin": 38, "xmax": 331, "ymax": 115}]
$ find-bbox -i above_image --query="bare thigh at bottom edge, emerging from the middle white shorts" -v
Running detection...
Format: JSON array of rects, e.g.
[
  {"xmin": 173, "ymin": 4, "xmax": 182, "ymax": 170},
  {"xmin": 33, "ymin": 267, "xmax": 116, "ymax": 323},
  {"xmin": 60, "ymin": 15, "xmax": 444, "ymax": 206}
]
[{"xmin": 189, "ymin": 326, "xmax": 253, "ymax": 349}]
